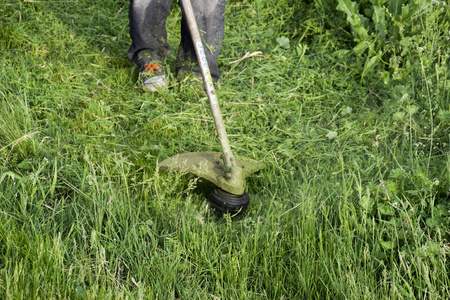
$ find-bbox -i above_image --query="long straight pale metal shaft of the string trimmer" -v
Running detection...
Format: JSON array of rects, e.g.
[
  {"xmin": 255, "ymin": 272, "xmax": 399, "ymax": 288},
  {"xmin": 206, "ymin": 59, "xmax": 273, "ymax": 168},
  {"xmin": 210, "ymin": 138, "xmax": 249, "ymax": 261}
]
[{"xmin": 182, "ymin": 0, "xmax": 235, "ymax": 178}]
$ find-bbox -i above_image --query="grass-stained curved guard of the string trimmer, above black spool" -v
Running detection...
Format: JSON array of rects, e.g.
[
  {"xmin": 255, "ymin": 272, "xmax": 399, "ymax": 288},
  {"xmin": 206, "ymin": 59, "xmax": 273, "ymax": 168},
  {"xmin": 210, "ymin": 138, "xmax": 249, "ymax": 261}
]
[{"xmin": 159, "ymin": 152, "xmax": 265, "ymax": 195}]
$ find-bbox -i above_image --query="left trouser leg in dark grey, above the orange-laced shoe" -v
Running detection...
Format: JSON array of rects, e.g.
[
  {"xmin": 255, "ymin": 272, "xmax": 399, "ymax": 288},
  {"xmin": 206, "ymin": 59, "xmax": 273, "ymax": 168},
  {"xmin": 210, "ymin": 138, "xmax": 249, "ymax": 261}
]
[{"xmin": 128, "ymin": 0, "xmax": 172, "ymax": 71}]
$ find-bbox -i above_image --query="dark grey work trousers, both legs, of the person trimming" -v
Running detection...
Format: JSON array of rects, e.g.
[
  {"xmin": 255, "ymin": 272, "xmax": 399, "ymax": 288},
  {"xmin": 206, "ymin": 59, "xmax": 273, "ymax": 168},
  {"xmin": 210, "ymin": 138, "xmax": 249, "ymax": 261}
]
[{"xmin": 128, "ymin": 0, "xmax": 225, "ymax": 81}]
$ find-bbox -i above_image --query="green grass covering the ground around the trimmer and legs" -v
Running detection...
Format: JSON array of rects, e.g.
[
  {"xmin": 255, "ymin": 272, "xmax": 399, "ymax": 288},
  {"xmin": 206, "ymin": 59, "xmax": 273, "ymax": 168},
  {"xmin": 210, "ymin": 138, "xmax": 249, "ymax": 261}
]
[{"xmin": 0, "ymin": 0, "xmax": 450, "ymax": 299}]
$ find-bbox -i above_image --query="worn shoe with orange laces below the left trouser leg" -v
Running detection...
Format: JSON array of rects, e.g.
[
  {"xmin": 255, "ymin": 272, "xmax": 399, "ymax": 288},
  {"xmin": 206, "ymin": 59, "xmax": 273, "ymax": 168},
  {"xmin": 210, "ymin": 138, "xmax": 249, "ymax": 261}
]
[{"xmin": 138, "ymin": 63, "xmax": 168, "ymax": 92}]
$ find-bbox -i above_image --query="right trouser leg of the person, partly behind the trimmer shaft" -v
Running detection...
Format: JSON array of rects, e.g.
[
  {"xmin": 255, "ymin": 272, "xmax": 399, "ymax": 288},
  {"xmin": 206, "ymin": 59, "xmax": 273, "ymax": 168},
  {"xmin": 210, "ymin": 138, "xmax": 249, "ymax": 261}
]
[{"xmin": 177, "ymin": 0, "xmax": 225, "ymax": 81}]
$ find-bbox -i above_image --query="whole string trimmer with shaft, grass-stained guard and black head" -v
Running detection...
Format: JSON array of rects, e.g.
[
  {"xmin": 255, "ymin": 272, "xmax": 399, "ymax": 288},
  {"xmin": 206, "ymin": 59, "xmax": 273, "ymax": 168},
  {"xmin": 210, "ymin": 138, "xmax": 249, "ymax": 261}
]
[{"xmin": 159, "ymin": 0, "xmax": 264, "ymax": 213}]
